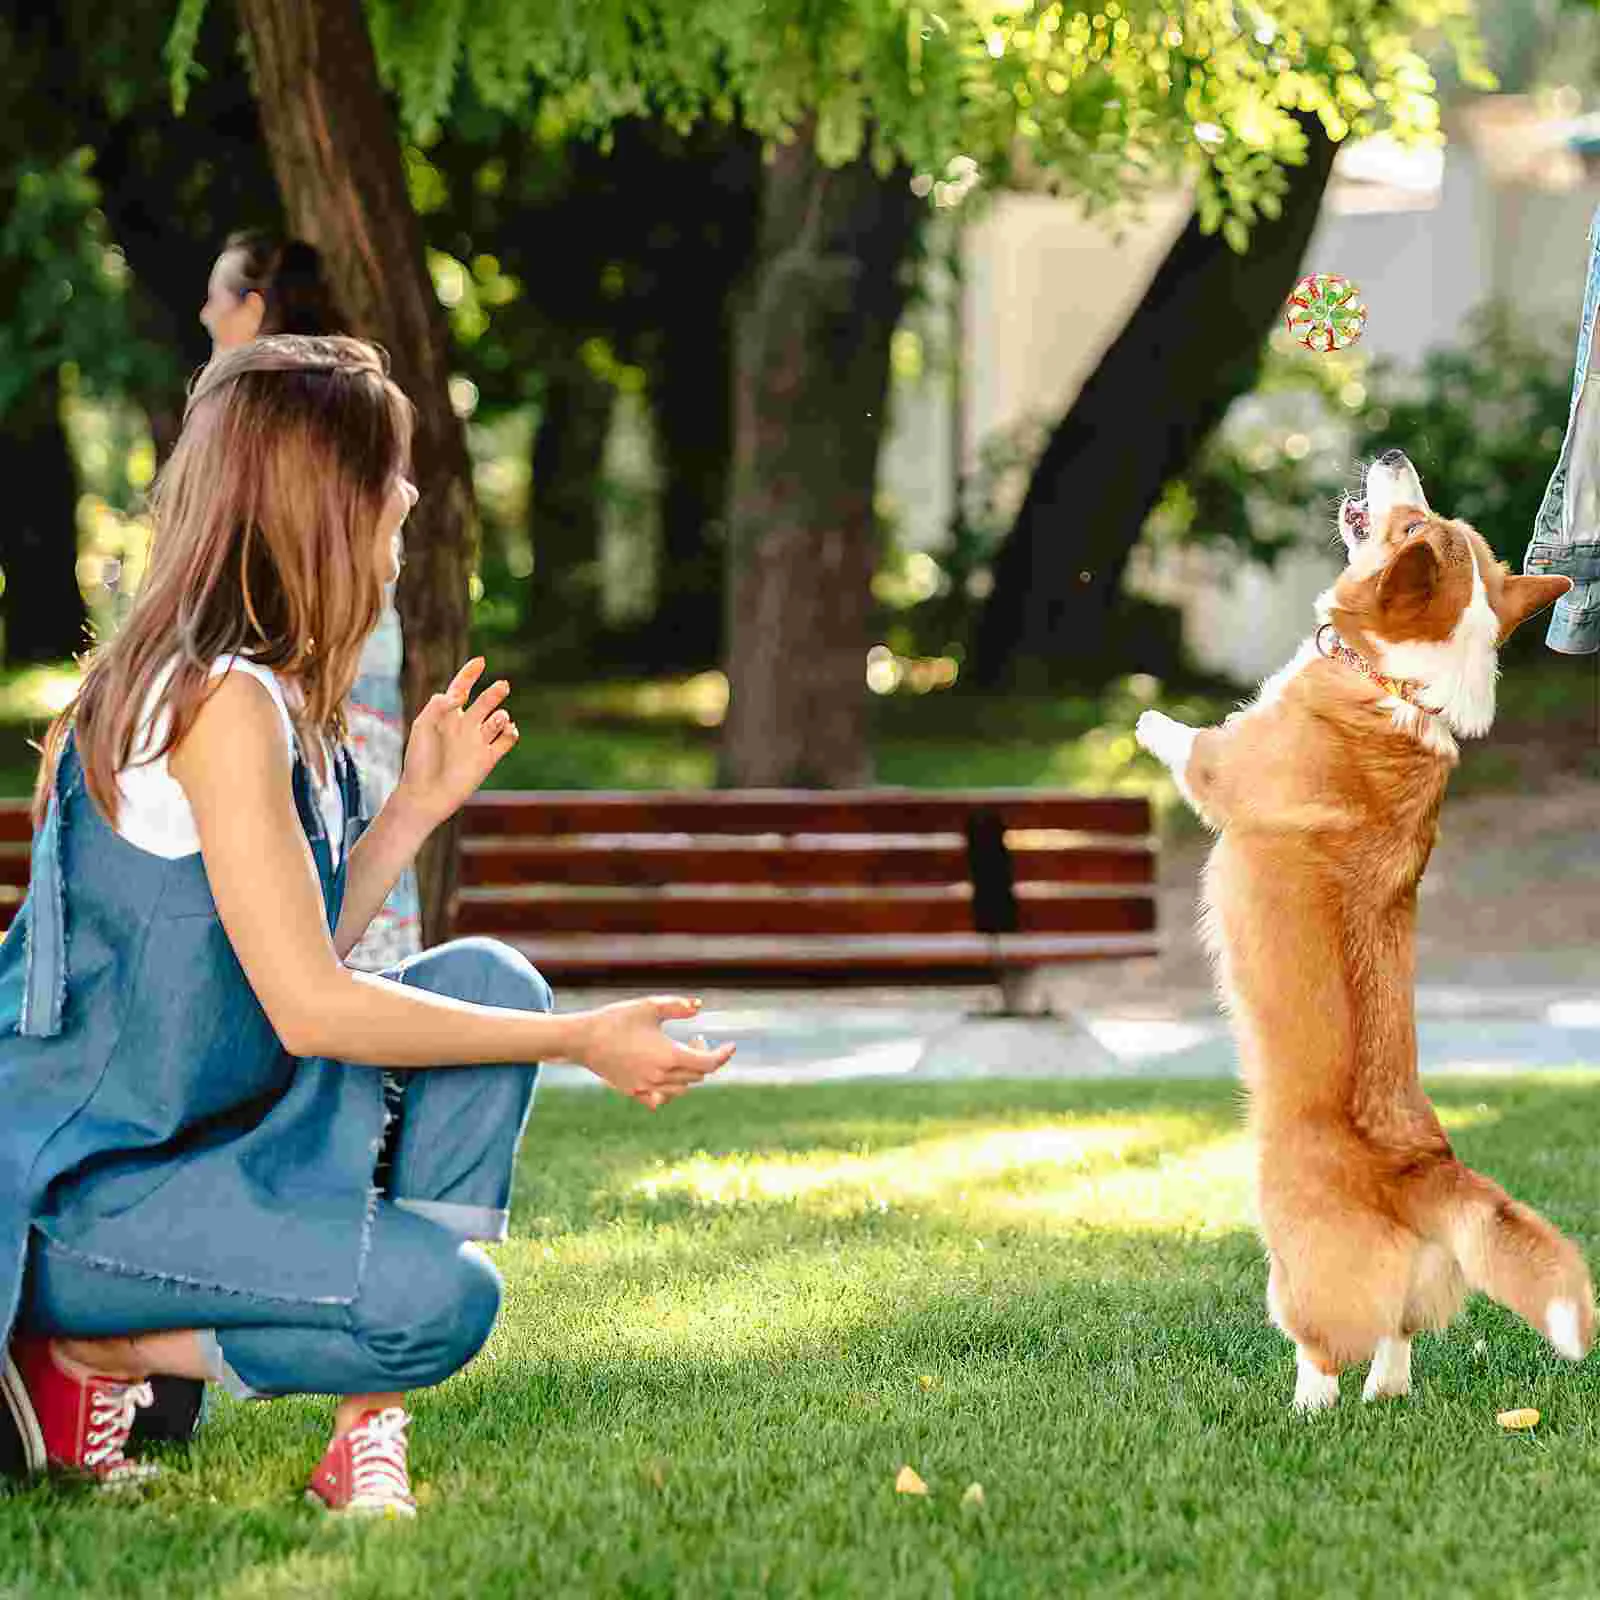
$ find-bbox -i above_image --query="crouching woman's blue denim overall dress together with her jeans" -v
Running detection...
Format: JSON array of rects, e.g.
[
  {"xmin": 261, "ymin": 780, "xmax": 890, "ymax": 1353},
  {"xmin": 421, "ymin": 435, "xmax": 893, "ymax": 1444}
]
[{"xmin": 0, "ymin": 741, "xmax": 552, "ymax": 1395}]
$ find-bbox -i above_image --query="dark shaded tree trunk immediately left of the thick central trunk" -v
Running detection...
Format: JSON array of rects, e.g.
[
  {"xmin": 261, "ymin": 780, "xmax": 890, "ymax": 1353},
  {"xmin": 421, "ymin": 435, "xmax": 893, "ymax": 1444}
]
[{"xmin": 650, "ymin": 300, "xmax": 733, "ymax": 669}]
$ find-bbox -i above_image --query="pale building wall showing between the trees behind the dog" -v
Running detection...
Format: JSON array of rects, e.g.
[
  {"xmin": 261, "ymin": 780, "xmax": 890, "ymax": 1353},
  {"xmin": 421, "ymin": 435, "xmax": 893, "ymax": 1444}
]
[{"xmin": 882, "ymin": 102, "xmax": 1600, "ymax": 683}]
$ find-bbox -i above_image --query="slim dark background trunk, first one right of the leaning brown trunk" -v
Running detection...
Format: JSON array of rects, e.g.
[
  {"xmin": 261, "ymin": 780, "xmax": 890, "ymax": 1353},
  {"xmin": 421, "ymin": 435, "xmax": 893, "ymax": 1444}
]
[{"xmin": 526, "ymin": 349, "xmax": 616, "ymax": 672}]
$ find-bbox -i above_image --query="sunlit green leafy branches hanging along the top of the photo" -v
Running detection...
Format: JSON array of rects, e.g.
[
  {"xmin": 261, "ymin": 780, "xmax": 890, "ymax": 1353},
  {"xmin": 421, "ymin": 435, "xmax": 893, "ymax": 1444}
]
[{"xmin": 353, "ymin": 0, "xmax": 1483, "ymax": 248}]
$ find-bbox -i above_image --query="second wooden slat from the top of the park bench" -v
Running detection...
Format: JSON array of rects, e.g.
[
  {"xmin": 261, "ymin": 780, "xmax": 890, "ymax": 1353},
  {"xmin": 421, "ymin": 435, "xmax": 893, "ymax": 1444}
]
[{"xmin": 461, "ymin": 837, "xmax": 1155, "ymax": 888}]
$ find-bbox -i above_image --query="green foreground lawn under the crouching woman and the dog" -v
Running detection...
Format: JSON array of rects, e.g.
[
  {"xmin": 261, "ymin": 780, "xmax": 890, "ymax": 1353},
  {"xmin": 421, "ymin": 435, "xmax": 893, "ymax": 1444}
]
[{"xmin": 9, "ymin": 1074, "xmax": 1600, "ymax": 1600}]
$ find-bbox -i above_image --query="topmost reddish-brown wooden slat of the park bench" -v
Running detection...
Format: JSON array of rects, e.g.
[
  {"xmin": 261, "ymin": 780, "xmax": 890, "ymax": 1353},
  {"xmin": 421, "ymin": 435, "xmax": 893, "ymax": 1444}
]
[{"xmin": 462, "ymin": 789, "xmax": 1150, "ymax": 838}]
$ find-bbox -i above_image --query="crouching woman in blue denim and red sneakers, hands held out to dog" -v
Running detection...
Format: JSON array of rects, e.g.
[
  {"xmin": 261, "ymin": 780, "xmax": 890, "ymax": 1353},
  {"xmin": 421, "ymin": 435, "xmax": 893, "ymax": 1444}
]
[{"xmin": 0, "ymin": 338, "xmax": 731, "ymax": 1515}]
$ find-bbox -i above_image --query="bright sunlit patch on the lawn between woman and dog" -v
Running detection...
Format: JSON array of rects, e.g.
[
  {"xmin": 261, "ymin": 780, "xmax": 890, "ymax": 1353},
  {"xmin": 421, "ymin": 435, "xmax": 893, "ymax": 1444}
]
[{"xmin": 490, "ymin": 1106, "xmax": 1250, "ymax": 1366}]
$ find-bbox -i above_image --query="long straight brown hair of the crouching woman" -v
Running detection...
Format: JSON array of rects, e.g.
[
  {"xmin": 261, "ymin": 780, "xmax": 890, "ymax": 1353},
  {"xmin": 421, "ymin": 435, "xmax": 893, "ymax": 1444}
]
[{"xmin": 34, "ymin": 334, "xmax": 411, "ymax": 822}]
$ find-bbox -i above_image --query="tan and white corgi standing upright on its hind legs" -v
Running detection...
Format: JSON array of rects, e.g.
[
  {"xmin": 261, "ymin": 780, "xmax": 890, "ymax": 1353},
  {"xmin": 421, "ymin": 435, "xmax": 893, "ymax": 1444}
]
[{"xmin": 1138, "ymin": 450, "xmax": 1595, "ymax": 1411}]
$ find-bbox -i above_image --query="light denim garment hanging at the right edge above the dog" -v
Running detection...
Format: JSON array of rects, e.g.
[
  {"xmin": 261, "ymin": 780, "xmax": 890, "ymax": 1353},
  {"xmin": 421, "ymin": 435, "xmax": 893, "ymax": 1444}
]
[{"xmin": 1523, "ymin": 208, "xmax": 1600, "ymax": 656}]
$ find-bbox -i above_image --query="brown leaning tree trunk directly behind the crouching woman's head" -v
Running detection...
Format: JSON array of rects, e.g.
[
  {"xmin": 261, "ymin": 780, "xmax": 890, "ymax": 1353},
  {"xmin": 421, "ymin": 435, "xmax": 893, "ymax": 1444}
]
[{"xmin": 238, "ymin": 0, "xmax": 475, "ymax": 942}]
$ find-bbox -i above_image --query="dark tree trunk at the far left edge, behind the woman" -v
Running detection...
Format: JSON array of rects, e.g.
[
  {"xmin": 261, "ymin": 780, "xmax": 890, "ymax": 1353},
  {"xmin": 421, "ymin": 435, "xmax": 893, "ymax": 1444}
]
[{"xmin": 0, "ymin": 370, "xmax": 86, "ymax": 667}]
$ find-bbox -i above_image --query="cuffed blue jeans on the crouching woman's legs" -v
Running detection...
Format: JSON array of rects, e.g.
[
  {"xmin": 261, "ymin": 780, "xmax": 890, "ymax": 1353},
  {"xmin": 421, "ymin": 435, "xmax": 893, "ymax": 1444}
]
[{"xmin": 18, "ymin": 939, "xmax": 552, "ymax": 1398}]
